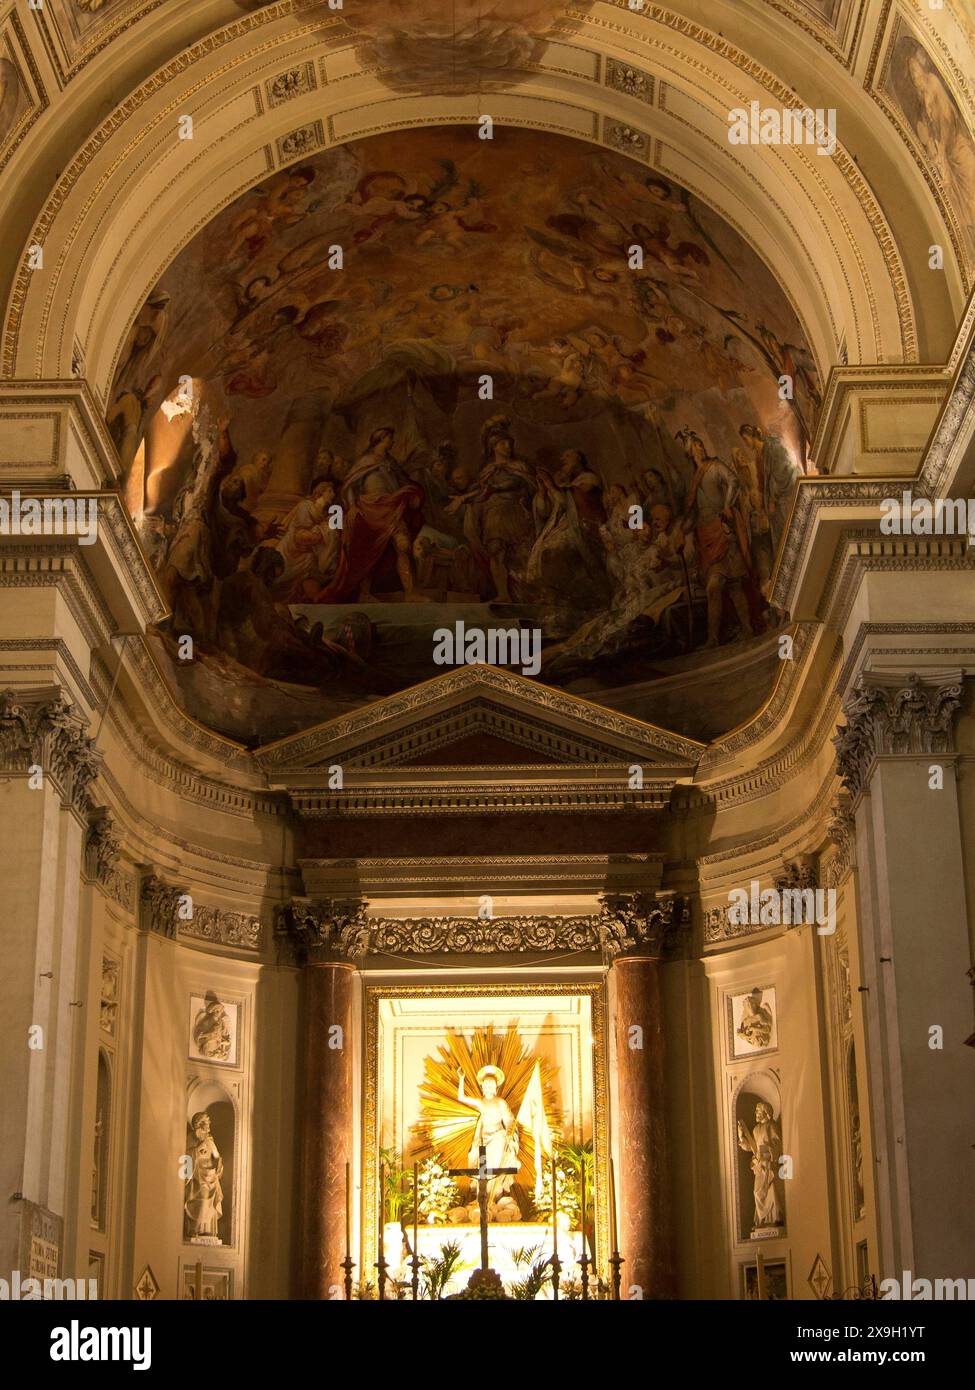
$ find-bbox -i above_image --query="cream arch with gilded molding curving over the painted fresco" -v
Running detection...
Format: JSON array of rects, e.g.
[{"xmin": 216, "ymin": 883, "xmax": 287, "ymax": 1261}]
[{"xmin": 3, "ymin": 6, "xmax": 962, "ymax": 395}]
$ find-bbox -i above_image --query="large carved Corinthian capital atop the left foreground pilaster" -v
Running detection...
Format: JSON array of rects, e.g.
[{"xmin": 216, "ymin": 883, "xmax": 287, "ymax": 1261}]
[{"xmin": 0, "ymin": 689, "xmax": 102, "ymax": 813}]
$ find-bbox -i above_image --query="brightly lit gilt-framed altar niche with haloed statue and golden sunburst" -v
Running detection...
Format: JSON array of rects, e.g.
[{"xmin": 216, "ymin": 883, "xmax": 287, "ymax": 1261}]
[{"xmin": 350, "ymin": 983, "xmax": 609, "ymax": 1298}]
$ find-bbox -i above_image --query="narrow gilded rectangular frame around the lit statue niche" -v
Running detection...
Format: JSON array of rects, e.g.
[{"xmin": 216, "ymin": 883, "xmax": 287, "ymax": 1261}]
[{"xmin": 359, "ymin": 980, "xmax": 609, "ymax": 1282}]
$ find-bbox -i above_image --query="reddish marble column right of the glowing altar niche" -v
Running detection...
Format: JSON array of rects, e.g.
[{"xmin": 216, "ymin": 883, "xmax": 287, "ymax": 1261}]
[{"xmin": 613, "ymin": 955, "xmax": 676, "ymax": 1298}]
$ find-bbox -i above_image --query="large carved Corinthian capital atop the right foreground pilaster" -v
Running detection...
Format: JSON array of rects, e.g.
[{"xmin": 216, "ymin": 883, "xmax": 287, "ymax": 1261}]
[{"xmin": 833, "ymin": 671, "xmax": 961, "ymax": 796}]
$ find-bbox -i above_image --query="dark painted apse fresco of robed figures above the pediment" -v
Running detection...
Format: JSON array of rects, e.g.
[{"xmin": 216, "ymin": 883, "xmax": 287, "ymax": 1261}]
[{"xmin": 118, "ymin": 126, "xmax": 819, "ymax": 742}]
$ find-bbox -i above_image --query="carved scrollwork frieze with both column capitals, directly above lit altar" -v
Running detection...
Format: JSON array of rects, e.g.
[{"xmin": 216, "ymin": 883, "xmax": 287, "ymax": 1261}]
[{"xmin": 275, "ymin": 892, "xmax": 690, "ymax": 965}]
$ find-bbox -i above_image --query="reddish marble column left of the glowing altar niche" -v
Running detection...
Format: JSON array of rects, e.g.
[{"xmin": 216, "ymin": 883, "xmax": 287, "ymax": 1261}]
[{"xmin": 302, "ymin": 962, "xmax": 356, "ymax": 1298}]
